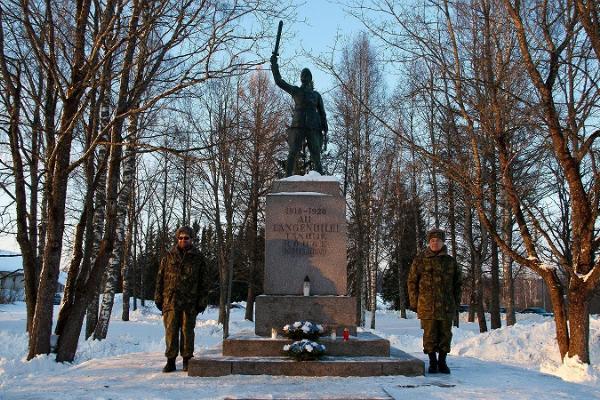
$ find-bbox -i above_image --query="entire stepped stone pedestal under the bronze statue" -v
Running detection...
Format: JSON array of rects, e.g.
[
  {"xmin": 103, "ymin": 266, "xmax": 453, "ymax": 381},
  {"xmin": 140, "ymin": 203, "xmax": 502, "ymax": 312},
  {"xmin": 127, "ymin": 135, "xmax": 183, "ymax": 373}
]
[{"xmin": 188, "ymin": 176, "xmax": 425, "ymax": 376}]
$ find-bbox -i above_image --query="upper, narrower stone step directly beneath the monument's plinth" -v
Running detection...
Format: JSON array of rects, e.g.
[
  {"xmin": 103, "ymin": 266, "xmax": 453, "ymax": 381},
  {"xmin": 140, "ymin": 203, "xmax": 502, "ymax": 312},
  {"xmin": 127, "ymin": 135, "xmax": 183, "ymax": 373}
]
[{"xmin": 223, "ymin": 332, "xmax": 390, "ymax": 357}]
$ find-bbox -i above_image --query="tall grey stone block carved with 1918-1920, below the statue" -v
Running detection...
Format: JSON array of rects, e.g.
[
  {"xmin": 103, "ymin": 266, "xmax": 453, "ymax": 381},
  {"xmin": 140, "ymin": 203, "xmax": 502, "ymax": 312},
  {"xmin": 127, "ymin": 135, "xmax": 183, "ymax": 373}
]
[{"xmin": 264, "ymin": 192, "xmax": 347, "ymax": 295}]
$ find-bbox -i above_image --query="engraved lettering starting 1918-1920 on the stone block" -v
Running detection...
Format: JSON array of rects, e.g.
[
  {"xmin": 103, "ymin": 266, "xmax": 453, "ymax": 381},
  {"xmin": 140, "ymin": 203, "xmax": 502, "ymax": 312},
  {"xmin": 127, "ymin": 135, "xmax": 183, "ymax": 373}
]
[{"xmin": 272, "ymin": 207, "xmax": 340, "ymax": 256}]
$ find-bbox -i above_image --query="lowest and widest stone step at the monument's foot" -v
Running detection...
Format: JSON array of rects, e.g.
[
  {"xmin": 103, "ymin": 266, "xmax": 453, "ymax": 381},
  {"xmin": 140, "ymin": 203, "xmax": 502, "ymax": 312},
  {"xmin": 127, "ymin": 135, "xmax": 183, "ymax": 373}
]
[{"xmin": 188, "ymin": 349, "xmax": 425, "ymax": 377}]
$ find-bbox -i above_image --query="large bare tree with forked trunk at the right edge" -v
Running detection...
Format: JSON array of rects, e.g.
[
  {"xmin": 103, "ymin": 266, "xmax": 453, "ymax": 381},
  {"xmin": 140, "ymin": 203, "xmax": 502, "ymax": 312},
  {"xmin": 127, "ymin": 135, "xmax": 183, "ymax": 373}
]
[{"xmin": 503, "ymin": 0, "xmax": 600, "ymax": 364}]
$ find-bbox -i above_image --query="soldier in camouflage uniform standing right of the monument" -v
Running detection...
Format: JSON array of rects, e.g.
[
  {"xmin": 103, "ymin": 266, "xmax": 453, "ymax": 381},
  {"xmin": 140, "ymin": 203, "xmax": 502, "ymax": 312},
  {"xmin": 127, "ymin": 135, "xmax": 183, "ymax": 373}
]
[{"xmin": 408, "ymin": 229, "xmax": 462, "ymax": 374}]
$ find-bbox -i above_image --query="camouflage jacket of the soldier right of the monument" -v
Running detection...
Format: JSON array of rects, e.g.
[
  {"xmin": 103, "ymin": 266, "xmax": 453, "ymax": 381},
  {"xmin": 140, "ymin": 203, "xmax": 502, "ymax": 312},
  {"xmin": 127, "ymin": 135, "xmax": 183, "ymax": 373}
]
[{"xmin": 408, "ymin": 246, "xmax": 462, "ymax": 320}]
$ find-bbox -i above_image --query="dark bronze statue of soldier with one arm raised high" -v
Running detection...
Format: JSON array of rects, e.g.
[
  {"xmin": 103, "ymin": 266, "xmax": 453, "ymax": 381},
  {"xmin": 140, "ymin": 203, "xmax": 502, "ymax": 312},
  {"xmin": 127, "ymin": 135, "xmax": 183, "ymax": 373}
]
[{"xmin": 271, "ymin": 22, "xmax": 328, "ymax": 176}]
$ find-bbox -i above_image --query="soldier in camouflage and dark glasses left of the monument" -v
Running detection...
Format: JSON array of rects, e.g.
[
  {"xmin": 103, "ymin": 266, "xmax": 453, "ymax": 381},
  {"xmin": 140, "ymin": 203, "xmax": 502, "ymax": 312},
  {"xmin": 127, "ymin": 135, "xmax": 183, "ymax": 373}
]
[{"xmin": 154, "ymin": 226, "xmax": 208, "ymax": 372}]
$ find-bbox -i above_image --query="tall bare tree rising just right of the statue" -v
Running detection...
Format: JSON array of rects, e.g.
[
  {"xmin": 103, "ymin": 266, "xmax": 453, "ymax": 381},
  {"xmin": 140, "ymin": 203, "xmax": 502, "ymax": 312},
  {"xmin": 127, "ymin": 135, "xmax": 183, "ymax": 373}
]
[{"xmin": 328, "ymin": 34, "xmax": 390, "ymax": 326}]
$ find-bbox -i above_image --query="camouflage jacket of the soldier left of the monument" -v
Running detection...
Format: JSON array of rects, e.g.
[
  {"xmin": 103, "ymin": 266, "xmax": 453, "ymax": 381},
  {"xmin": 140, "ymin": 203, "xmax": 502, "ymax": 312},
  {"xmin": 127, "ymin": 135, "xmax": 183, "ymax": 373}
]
[{"xmin": 154, "ymin": 246, "xmax": 208, "ymax": 312}]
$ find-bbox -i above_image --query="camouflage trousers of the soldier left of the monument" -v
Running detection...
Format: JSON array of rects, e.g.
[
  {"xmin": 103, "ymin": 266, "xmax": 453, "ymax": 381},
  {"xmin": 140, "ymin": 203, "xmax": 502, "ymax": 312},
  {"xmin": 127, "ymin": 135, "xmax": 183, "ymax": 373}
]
[{"xmin": 163, "ymin": 310, "xmax": 198, "ymax": 358}]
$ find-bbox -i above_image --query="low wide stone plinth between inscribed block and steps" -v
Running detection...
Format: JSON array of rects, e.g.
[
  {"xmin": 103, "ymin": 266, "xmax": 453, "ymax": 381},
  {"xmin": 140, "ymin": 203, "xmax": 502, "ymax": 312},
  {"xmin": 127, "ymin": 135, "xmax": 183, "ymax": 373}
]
[{"xmin": 254, "ymin": 295, "xmax": 356, "ymax": 337}]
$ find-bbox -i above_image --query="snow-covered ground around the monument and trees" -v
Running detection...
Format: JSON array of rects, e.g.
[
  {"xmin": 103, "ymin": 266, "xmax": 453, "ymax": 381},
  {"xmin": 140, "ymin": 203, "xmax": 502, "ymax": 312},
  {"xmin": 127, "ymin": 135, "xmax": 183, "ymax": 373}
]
[{"xmin": 0, "ymin": 301, "xmax": 600, "ymax": 400}]
